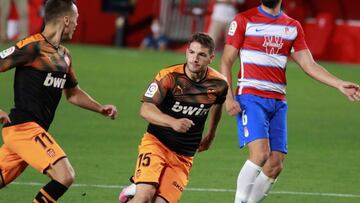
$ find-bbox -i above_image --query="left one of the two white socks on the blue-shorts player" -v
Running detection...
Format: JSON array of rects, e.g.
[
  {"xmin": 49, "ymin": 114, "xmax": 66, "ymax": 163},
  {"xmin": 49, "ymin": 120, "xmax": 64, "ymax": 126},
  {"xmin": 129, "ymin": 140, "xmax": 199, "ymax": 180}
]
[{"xmin": 235, "ymin": 160, "xmax": 261, "ymax": 203}]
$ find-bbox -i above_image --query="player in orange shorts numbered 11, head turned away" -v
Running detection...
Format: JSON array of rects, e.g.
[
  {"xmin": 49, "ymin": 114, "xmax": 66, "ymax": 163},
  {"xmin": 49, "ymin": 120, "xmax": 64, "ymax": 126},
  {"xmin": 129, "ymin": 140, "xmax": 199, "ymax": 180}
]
[{"xmin": 0, "ymin": 0, "xmax": 117, "ymax": 202}]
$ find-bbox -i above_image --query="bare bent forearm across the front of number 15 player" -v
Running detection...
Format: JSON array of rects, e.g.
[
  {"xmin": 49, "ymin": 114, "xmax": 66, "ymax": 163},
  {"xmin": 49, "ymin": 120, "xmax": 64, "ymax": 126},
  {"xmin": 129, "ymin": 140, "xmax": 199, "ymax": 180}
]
[{"xmin": 140, "ymin": 102, "xmax": 194, "ymax": 133}]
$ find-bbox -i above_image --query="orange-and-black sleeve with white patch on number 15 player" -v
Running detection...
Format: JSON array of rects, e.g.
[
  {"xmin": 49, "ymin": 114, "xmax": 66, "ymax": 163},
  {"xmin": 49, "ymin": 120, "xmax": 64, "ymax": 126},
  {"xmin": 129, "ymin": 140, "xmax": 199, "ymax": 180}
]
[{"xmin": 142, "ymin": 72, "xmax": 174, "ymax": 105}]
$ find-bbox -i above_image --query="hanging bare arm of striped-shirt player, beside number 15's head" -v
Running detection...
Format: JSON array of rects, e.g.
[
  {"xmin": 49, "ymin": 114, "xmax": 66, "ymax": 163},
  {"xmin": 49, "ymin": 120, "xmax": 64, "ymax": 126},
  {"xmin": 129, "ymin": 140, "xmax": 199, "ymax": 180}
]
[{"xmin": 220, "ymin": 45, "xmax": 241, "ymax": 116}]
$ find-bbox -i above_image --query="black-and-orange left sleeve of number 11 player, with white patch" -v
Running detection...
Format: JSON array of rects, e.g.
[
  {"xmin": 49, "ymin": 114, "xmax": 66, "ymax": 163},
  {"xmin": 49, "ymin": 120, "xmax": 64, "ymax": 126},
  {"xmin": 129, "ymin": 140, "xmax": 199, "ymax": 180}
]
[{"xmin": 0, "ymin": 43, "xmax": 39, "ymax": 72}]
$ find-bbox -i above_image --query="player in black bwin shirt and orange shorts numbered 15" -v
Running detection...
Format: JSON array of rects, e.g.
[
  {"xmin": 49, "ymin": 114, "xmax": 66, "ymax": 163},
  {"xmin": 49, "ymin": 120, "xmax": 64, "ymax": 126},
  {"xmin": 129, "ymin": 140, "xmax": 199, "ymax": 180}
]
[{"xmin": 119, "ymin": 33, "xmax": 228, "ymax": 203}]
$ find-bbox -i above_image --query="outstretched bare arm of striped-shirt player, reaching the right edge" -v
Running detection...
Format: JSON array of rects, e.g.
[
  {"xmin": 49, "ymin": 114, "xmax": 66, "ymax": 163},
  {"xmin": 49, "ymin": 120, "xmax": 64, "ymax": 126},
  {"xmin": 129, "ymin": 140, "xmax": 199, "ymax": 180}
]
[{"xmin": 291, "ymin": 49, "xmax": 360, "ymax": 101}]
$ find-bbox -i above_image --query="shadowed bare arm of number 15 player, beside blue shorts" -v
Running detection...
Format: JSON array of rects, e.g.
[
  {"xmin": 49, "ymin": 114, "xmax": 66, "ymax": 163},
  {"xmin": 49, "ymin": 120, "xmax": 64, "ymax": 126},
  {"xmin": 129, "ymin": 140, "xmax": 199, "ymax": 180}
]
[{"xmin": 198, "ymin": 104, "xmax": 222, "ymax": 152}]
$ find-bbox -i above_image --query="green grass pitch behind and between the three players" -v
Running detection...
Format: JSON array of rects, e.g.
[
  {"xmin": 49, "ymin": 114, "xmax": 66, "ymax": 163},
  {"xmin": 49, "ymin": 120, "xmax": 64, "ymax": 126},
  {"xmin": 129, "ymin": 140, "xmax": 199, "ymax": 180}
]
[{"xmin": 0, "ymin": 45, "xmax": 360, "ymax": 203}]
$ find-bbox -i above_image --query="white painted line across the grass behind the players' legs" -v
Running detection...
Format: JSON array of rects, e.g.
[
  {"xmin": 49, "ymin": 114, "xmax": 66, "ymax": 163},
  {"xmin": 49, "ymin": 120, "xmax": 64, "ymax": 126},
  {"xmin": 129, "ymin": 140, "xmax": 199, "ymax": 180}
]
[{"xmin": 11, "ymin": 182, "xmax": 360, "ymax": 198}]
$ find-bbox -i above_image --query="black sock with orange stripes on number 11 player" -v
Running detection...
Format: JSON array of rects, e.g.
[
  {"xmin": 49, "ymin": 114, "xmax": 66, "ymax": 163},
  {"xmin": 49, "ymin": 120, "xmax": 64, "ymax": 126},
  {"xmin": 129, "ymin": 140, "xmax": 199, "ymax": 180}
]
[{"xmin": 34, "ymin": 180, "xmax": 68, "ymax": 203}]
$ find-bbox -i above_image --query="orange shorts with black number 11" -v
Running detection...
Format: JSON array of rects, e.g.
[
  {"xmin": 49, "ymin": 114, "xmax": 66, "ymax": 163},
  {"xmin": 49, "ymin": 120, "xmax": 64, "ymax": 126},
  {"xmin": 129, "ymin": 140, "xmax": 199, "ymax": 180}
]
[{"xmin": 0, "ymin": 122, "xmax": 66, "ymax": 184}]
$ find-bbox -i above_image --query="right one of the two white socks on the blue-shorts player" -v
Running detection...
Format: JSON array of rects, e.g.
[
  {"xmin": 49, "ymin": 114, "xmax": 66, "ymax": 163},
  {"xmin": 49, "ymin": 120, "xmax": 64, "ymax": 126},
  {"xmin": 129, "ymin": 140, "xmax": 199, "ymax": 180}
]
[{"xmin": 249, "ymin": 172, "xmax": 276, "ymax": 203}]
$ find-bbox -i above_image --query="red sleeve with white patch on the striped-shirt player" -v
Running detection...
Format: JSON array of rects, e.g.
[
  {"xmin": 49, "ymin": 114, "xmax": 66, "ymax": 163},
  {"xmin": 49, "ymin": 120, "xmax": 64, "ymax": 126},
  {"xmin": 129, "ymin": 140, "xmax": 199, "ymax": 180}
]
[{"xmin": 225, "ymin": 14, "xmax": 246, "ymax": 49}]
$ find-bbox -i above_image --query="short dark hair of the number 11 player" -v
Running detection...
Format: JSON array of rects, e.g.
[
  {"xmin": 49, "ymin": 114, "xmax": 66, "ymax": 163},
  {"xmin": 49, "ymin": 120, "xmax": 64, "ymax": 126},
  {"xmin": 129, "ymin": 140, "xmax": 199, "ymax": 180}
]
[{"xmin": 44, "ymin": 0, "xmax": 75, "ymax": 23}]
